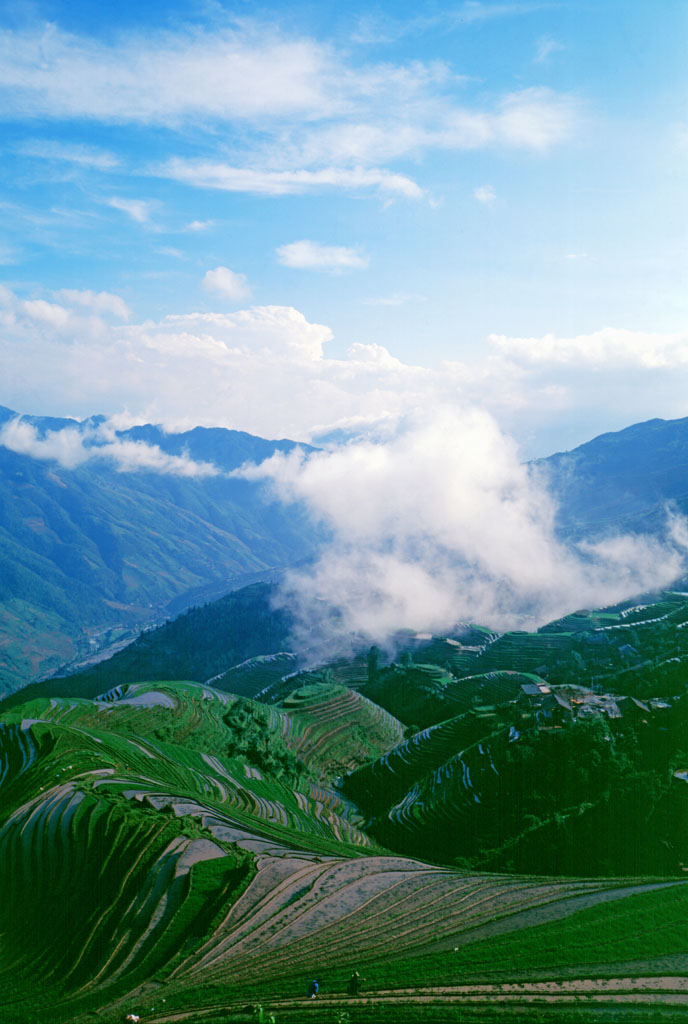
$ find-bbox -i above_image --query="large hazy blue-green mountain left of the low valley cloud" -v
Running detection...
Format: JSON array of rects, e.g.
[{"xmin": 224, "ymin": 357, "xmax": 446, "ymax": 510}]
[{"xmin": 0, "ymin": 408, "xmax": 313, "ymax": 695}]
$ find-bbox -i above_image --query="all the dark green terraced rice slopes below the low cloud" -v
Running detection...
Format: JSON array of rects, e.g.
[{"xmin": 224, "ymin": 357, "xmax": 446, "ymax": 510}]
[{"xmin": 0, "ymin": 585, "xmax": 688, "ymax": 1024}]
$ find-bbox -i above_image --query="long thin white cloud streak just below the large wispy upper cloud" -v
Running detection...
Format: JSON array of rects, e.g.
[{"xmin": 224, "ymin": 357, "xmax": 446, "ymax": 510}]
[{"xmin": 157, "ymin": 158, "xmax": 423, "ymax": 199}]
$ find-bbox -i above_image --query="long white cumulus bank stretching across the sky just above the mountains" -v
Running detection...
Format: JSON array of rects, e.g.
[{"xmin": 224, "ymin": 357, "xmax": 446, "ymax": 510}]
[{"xmin": 0, "ymin": 286, "xmax": 688, "ymax": 456}]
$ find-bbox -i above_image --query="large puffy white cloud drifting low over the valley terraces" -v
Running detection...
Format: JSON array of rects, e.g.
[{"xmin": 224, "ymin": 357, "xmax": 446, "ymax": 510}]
[{"xmin": 239, "ymin": 408, "xmax": 686, "ymax": 643}]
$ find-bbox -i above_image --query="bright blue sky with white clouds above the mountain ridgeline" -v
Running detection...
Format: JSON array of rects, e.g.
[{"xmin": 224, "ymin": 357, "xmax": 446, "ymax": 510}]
[{"xmin": 0, "ymin": 0, "xmax": 688, "ymax": 458}]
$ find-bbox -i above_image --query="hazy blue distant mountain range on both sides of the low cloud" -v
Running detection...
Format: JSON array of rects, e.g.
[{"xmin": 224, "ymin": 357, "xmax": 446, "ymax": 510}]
[{"xmin": 0, "ymin": 407, "xmax": 688, "ymax": 696}]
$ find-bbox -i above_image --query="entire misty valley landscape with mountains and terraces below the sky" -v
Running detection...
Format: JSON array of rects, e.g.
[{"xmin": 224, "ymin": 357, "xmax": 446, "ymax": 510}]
[{"xmin": 0, "ymin": 410, "xmax": 688, "ymax": 1024}]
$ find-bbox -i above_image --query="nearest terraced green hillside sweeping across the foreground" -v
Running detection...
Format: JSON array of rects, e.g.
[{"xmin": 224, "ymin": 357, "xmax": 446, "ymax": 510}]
[{"xmin": 0, "ymin": 683, "xmax": 686, "ymax": 1024}]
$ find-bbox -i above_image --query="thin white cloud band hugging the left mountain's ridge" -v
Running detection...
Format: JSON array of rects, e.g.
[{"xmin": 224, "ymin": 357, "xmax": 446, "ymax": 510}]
[{"xmin": 0, "ymin": 418, "xmax": 219, "ymax": 478}]
